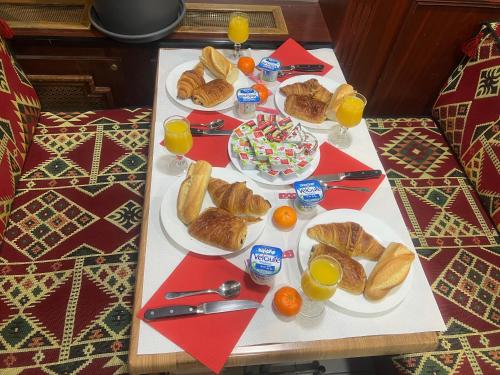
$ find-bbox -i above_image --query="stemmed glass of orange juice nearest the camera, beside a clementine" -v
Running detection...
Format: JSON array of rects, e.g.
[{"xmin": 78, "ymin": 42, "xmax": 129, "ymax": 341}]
[{"xmin": 300, "ymin": 255, "xmax": 342, "ymax": 318}]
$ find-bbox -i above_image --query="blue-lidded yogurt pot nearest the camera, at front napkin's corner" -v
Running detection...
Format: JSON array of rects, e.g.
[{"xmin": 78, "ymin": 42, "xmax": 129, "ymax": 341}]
[{"xmin": 248, "ymin": 245, "xmax": 283, "ymax": 285}]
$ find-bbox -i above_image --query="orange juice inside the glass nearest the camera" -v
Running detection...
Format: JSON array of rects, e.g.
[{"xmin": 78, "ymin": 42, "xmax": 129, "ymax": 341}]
[{"xmin": 301, "ymin": 256, "xmax": 342, "ymax": 301}]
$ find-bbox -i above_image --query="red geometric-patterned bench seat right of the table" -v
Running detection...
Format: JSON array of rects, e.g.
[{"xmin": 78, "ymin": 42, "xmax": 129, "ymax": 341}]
[{"xmin": 368, "ymin": 119, "xmax": 500, "ymax": 375}]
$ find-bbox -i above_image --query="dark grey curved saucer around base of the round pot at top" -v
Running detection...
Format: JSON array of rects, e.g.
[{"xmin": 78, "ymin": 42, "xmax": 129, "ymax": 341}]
[{"xmin": 90, "ymin": 0, "xmax": 186, "ymax": 43}]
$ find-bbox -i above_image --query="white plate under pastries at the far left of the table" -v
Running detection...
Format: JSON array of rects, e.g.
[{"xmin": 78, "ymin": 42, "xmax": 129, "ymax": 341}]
[{"xmin": 165, "ymin": 60, "xmax": 250, "ymax": 111}]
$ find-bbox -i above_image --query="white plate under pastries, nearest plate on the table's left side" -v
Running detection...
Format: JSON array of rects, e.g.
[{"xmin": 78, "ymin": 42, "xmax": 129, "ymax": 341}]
[{"xmin": 160, "ymin": 167, "xmax": 271, "ymax": 256}]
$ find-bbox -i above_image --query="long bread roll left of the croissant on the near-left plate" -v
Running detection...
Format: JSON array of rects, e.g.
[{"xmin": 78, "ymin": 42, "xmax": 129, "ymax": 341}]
[{"xmin": 177, "ymin": 160, "xmax": 212, "ymax": 224}]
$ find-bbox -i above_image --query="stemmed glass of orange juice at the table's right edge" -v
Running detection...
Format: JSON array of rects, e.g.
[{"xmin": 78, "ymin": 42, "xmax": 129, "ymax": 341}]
[{"xmin": 329, "ymin": 92, "xmax": 366, "ymax": 148}]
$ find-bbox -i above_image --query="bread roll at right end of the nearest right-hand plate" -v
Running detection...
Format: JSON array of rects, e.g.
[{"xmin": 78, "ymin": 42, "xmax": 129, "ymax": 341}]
[{"xmin": 364, "ymin": 242, "xmax": 415, "ymax": 301}]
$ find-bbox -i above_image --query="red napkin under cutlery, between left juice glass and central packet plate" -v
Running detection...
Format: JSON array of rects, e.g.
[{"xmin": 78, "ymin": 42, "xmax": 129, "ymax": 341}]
[{"xmin": 160, "ymin": 111, "xmax": 241, "ymax": 168}]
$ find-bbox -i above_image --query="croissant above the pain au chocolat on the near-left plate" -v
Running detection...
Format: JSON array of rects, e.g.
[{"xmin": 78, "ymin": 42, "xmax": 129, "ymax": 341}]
[{"xmin": 208, "ymin": 178, "xmax": 271, "ymax": 216}]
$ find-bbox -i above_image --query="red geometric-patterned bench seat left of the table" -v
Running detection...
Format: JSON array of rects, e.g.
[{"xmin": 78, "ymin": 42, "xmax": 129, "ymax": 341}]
[{"xmin": 0, "ymin": 108, "xmax": 150, "ymax": 375}]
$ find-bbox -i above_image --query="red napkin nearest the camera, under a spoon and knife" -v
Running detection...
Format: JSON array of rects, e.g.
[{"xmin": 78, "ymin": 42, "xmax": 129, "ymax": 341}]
[{"xmin": 138, "ymin": 252, "xmax": 269, "ymax": 373}]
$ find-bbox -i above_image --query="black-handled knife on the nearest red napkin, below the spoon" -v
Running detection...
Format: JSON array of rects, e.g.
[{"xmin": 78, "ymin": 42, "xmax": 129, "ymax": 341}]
[{"xmin": 144, "ymin": 299, "xmax": 262, "ymax": 320}]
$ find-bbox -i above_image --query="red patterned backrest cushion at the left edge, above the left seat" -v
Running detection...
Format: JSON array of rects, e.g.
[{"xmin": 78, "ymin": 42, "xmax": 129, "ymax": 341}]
[{"xmin": 0, "ymin": 37, "xmax": 40, "ymax": 243}]
